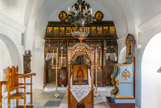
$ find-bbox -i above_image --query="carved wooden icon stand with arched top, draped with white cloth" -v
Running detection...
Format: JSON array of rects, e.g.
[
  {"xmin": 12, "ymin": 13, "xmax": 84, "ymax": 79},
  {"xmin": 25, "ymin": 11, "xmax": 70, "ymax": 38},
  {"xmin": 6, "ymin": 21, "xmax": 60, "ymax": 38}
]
[{"xmin": 68, "ymin": 43, "xmax": 95, "ymax": 108}]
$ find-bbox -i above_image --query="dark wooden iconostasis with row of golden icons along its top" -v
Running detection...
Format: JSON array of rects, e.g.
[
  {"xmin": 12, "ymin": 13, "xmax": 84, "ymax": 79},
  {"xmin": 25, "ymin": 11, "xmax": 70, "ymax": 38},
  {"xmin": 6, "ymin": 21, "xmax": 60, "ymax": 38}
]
[{"xmin": 44, "ymin": 21, "xmax": 118, "ymax": 87}]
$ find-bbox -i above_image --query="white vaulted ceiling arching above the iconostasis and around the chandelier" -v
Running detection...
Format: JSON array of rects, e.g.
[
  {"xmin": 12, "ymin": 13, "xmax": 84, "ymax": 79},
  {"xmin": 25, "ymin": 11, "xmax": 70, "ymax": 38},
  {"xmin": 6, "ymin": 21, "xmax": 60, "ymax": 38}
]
[{"xmin": 0, "ymin": 0, "xmax": 161, "ymax": 44}]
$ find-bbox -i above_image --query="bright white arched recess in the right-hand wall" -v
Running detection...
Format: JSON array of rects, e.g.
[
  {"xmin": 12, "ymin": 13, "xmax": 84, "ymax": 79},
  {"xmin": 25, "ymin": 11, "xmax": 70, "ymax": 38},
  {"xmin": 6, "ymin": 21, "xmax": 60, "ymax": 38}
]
[{"xmin": 141, "ymin": 33, "xmax": 161, "ymax": 108}]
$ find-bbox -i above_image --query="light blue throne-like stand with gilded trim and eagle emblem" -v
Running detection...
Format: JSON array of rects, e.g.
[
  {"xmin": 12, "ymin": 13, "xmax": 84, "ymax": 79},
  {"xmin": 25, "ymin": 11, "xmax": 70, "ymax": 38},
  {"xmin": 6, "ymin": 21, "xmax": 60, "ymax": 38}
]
[{"xmin": 107, "ymin": 34, "xmax": 135, "ymax": 108}]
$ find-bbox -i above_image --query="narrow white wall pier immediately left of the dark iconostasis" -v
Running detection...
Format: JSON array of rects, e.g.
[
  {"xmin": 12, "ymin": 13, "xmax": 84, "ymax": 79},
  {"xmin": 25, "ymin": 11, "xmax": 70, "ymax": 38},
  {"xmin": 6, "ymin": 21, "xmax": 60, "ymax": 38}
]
[{"xmin": 31, "ymin": 34, "xmax": 44, "ymax": 89}]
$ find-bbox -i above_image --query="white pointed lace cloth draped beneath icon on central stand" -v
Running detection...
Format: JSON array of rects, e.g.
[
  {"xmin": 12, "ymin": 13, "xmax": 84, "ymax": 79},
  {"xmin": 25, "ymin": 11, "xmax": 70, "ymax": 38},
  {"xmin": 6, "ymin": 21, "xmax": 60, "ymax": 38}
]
[{"xmin": 70, "ymin": 69, "xmax": 91, "ymax": 102}]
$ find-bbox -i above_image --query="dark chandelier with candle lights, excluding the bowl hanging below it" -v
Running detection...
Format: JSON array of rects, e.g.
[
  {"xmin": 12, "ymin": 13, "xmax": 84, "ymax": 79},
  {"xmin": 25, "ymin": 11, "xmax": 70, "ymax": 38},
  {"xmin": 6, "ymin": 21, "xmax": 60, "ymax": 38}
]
[{"xmin": 66, "ymin": 0, "xmax": 94, "ymax": 28}]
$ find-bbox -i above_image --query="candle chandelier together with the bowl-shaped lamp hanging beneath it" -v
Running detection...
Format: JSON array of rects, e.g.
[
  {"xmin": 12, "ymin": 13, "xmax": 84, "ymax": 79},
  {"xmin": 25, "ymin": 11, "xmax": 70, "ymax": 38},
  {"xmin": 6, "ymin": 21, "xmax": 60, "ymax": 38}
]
[{"xmin": 66, "ymin": 0, "xmax": 94, "ymax": 42}]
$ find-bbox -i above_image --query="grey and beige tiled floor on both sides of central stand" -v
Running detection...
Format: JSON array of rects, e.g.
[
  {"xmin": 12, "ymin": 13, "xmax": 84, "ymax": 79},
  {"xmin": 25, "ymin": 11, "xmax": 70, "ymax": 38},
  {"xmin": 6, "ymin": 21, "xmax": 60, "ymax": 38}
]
[{"xmin": 33, "ymin": 88, "xmax": 109, "ymax": 108}]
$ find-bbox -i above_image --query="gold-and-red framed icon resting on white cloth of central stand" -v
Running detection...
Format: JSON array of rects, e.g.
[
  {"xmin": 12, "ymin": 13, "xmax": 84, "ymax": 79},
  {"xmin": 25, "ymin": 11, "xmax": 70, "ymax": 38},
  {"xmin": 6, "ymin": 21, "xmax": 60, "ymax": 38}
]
[{"xmin": 73, "ymin": 65, "xmax": 88, "ymax": 85}]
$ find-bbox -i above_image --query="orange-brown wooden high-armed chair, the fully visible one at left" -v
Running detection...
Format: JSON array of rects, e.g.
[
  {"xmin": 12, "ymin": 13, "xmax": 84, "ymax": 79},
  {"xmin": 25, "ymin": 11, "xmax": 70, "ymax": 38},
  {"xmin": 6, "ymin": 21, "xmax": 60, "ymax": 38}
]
[{"xmin": 7, "ymin": 66, "xmax": 36, "ymax": 108}]
